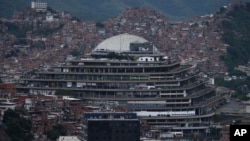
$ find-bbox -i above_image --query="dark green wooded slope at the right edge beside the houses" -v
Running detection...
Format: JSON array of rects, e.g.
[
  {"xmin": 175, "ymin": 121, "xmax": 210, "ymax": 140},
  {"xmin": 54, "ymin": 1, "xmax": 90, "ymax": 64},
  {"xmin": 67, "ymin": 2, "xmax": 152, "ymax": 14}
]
[{"xmin": 221, "ymin": 3, "xmax": 250, "ymax": 70}]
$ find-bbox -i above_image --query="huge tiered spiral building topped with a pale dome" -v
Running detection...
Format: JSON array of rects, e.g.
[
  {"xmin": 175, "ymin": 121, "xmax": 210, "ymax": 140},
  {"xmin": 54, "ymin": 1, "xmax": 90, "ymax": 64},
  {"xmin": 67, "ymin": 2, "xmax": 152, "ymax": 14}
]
[{"xmin": 17, "ymin": 34, "xmax": 229, "ymax": 137}]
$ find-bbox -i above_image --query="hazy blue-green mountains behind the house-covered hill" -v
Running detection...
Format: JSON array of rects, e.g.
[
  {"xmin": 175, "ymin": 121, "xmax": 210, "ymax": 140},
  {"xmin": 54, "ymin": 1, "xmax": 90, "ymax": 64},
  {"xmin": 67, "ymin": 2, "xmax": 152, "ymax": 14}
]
[{"xmin": 0, "ymin": 0, "xmax": 250, "ymax": 21}]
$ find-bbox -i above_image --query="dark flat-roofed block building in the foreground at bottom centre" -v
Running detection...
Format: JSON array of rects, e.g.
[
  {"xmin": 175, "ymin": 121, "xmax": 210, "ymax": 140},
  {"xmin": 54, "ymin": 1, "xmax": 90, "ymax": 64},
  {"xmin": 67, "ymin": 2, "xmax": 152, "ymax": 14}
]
[{"xmin": 83, "ymin": 112, "xmax": 140, "ymax": 141}]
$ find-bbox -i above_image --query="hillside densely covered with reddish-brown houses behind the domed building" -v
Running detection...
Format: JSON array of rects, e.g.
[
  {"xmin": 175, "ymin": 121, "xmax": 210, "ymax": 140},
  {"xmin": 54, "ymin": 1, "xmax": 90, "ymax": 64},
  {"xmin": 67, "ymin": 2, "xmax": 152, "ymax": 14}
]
[{"xmin": 0, "ymin": 2, "xmax": 250, "ymax": 77}]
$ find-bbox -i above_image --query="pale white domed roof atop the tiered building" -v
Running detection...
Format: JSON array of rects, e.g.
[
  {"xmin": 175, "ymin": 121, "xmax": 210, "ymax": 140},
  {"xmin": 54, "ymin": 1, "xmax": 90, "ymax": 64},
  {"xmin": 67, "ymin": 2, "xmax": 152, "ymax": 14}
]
[{"xmin": 94, "ymin": 33, "xmax": 155, "ymax": 52}]
